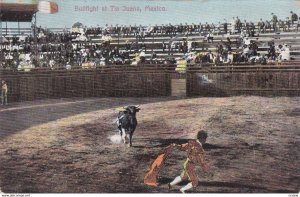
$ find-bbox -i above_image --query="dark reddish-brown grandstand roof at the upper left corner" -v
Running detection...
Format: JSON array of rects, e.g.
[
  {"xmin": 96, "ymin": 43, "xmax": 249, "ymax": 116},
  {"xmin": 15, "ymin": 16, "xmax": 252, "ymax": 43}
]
[{"xmin": 0, "ymin": 3, "xmax": 38, "ymax": 22}]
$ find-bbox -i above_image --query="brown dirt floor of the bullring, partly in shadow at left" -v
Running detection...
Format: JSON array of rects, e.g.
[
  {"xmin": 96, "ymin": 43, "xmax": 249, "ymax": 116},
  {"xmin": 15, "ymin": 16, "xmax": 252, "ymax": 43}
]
[{"xmin": 0, "ymin": 97, "xmax": 300, "ymax": 193}]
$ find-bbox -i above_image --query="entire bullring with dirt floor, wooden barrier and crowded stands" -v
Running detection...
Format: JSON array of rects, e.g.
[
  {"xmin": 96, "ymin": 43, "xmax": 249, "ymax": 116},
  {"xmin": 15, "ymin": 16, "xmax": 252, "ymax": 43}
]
[{"xmin": 0, "ymin": 0, "xmax": 300, "ymax": 193}]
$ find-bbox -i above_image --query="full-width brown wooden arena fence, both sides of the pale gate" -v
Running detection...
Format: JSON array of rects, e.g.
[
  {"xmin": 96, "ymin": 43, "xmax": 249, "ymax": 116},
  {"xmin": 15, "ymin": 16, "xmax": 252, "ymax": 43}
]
[{"xmin": 0, "ymin": 65, "xmax": 300, "ymax": 102}]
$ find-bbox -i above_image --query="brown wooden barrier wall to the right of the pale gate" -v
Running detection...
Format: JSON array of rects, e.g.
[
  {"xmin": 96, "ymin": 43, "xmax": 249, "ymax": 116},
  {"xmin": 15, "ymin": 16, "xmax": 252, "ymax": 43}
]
[{"xmin": 187, "ymin": 70, "xmax": 300, "ymax": 97}]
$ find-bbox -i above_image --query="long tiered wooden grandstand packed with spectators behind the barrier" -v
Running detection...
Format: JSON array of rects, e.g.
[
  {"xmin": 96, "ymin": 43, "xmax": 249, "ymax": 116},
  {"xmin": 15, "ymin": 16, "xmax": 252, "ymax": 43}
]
[{"xmin": 0, "ymin": 10, "xmax": 300, "ymax": 69}]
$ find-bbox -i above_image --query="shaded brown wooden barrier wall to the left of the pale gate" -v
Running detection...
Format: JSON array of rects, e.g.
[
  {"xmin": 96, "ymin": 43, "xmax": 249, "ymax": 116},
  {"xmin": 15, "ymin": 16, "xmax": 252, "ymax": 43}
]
[{"xmin": 0, "ymin": 70, "xmax": 171, "ymax": 102}]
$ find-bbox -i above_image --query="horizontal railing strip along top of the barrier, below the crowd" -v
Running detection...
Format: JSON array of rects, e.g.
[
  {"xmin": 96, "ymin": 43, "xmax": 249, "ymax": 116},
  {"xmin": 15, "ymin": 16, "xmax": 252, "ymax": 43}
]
[{"xmin": 0, "ymin": 61, "xmax": 300, "ymax": 74}]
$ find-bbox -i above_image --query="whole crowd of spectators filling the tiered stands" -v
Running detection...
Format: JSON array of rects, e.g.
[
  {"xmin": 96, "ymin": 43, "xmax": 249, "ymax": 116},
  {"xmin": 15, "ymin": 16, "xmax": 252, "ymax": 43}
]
[{"xmin": 0, "ymin": 11, "xmax": 300, "ymax": 70}]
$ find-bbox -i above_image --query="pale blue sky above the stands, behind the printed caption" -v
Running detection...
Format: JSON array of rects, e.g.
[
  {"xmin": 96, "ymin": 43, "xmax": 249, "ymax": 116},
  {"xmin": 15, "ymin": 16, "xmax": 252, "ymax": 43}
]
[{"xmin": 2, "ymin": 0, "xmax": 300, "ymax": 27}]
